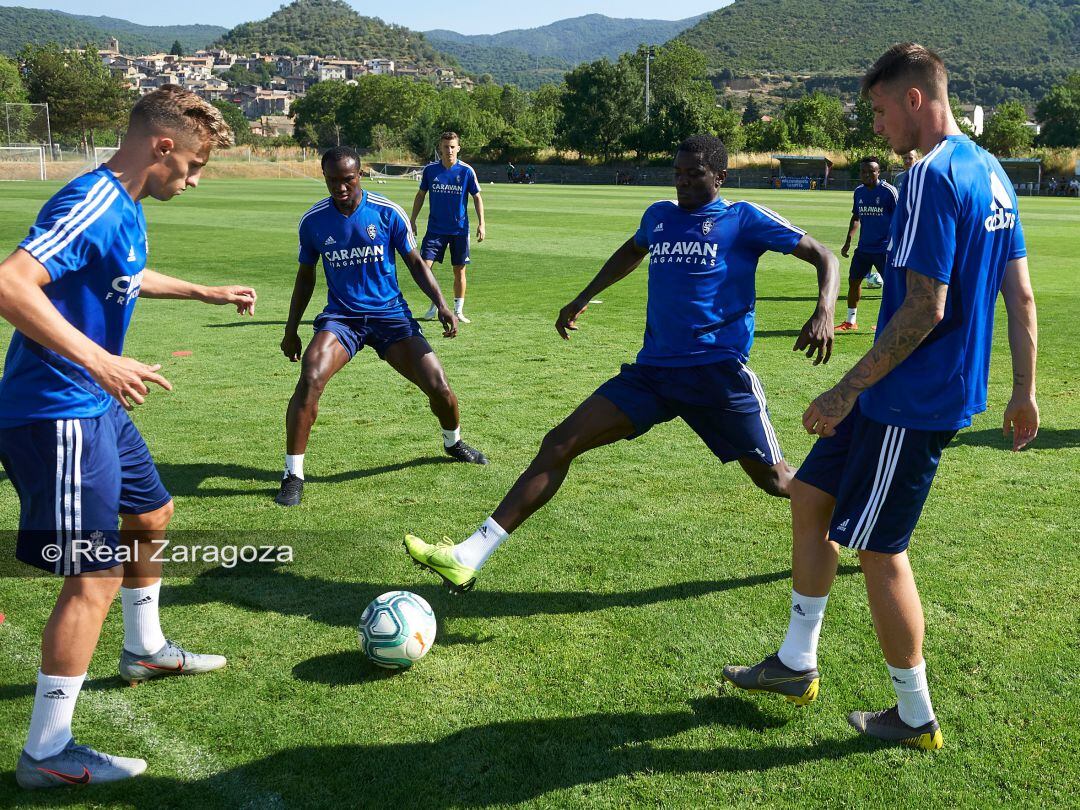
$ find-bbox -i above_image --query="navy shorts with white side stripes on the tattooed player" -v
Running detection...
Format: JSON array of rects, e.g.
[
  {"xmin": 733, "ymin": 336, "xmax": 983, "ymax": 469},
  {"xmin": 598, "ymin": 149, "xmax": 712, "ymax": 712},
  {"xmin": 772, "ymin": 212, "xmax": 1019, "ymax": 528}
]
[{"xmin": 795, "ymin": 403, "xmax": 956, "ymax": 554}]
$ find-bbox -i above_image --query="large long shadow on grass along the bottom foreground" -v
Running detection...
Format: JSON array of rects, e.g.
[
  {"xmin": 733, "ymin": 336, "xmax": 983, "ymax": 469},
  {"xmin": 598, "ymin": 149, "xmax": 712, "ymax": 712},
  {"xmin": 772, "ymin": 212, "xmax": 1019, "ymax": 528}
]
[{"xmin": 0, "ymin": 696, "xmax": 880, "ymax": 808}]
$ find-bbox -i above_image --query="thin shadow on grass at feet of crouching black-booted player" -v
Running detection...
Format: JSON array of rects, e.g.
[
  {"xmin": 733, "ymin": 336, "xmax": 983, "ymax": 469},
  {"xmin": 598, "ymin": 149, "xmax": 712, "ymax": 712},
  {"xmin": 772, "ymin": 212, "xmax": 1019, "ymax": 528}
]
[{"xmin": 158, "ymin": 456, "xmax": 457, "ymax": 498}]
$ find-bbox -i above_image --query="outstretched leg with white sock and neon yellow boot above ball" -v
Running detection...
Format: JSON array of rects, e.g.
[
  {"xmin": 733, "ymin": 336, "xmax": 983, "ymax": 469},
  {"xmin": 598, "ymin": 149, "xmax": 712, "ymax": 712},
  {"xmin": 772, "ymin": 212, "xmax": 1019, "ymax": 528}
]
[{"xmin": 405, "ymin": 394, "xmax": 634, "ymax": 593}]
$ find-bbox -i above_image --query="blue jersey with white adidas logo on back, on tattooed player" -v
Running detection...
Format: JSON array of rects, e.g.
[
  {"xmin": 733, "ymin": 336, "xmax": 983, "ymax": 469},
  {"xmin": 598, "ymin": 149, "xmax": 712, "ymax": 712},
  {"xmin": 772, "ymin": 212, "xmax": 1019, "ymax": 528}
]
[{"xmin": 860, "ymin": 135, "xmax": 1027, "ymax": 430}]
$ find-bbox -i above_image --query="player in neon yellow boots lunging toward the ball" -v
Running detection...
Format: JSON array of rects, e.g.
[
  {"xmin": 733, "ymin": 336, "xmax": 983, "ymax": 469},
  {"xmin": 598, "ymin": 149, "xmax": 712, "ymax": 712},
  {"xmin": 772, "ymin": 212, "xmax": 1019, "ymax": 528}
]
[{"xmin": 405, "ymin": 135, "xmax": 838, "ymax": 591}]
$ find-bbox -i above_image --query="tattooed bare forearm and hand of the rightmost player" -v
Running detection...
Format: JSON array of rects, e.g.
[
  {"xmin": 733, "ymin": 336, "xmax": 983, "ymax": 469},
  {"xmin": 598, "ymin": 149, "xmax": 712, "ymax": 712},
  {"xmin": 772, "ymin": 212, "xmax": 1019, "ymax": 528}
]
[{"xmin": 802, "ymin": 270, "xmax": 948, "ymax": 436}]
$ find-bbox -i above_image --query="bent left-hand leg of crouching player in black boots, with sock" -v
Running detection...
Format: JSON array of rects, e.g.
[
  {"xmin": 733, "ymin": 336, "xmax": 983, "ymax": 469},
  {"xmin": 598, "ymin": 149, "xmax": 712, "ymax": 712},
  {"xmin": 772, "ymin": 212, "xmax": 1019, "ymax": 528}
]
[{"xmin": 274, "ymin": 327, "xmax": 352, "ymax": 507}]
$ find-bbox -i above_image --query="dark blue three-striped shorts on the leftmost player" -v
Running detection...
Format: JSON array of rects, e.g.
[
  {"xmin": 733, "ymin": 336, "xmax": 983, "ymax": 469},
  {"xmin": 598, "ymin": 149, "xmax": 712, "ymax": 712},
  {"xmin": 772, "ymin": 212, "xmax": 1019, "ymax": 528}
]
[{"xmin": 0, "ymin": 402, "xmax": 172, "ymax": 577}]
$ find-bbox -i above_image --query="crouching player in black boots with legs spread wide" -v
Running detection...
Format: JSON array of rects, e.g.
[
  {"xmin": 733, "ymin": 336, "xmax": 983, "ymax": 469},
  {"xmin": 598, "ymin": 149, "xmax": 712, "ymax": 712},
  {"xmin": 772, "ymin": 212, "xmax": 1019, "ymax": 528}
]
[{"xmin": 274, "ymin": 147, "xmax": 487, "ymax": 507}]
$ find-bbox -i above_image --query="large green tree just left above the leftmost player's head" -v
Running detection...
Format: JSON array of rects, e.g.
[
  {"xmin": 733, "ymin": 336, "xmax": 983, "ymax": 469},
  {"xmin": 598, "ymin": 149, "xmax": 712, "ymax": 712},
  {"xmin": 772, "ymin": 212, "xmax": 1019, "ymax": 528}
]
[{"xmin": 19, "ymin": 43, "xmax": 136, "ymax": 143}]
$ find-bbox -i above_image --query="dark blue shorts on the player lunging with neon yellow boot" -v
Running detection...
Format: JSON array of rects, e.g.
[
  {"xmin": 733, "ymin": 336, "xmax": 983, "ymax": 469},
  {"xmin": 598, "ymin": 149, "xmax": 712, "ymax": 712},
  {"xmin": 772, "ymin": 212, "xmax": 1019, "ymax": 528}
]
[{"xmin": 596, "ymin": 359, "xmax": 784, "ymax": 467}]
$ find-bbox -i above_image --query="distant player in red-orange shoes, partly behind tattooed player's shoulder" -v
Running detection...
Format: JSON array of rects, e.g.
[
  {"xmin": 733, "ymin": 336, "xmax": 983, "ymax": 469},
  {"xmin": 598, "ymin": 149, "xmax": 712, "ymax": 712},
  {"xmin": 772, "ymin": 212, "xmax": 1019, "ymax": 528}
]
[{"xmin": 836, "ymin": 157, "xmax": 896, "ymax": 332}]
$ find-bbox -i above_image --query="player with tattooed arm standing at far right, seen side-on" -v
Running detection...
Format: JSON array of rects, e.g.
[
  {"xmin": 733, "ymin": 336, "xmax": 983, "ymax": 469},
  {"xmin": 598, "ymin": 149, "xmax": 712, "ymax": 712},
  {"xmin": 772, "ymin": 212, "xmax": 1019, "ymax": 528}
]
[{"xmin": 724, "ymin": 42, "xmax": 1039, "ymax": 750}]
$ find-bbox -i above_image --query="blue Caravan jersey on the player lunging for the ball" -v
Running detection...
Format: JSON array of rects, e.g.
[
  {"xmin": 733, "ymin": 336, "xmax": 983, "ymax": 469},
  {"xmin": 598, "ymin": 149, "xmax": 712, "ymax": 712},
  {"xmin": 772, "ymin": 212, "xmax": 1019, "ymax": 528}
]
[{"xmin": 634, "ymin": 200, "xmax": 805, "ymax": 366}]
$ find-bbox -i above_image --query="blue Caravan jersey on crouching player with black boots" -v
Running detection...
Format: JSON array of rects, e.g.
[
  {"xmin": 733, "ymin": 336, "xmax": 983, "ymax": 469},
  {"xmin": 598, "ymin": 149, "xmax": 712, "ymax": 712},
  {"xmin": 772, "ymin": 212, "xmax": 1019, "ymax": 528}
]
[{"xmin": 299, "ymin": 191, "xmax": 416, "ymax": 318}]
